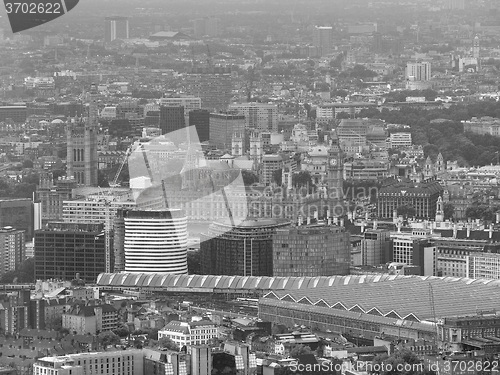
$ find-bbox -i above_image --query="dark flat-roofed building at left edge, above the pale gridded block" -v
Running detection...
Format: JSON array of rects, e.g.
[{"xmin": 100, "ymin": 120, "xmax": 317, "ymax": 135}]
[{"xmin": 0, "ymin": 198, "xmax": 34, "ymax": 241}]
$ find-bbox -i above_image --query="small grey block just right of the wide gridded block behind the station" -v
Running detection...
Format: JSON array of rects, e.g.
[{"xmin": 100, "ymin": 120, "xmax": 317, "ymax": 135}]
[{"xmin": 361, "ymin": 229, "xmax": 392, "ymax": 266}]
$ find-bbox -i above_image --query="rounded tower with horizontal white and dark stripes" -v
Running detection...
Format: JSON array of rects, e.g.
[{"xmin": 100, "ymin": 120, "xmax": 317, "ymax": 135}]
[{"xmin": 124, "ymin": 209, "xmax": 187, "ymax": 274}]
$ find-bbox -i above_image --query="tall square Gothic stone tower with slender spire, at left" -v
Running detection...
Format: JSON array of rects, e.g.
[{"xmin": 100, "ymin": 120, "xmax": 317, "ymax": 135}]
[{"xmin": 66, "ymin": 85, "xmax": 99, "ymax": 186}]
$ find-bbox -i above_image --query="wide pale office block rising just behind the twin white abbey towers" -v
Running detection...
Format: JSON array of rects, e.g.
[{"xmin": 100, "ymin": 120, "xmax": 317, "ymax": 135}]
[{"xmin": 229, "ymin": 103, "xmax": 278, "ymax": 132}]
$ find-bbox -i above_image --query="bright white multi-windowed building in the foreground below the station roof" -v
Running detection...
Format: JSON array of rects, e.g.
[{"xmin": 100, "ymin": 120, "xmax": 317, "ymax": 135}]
[{"xmin": 158, "ymin": 320, "xmax": 218, "ymax": 349}]
